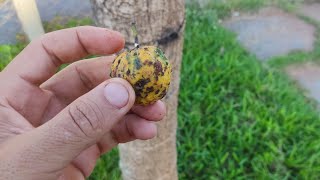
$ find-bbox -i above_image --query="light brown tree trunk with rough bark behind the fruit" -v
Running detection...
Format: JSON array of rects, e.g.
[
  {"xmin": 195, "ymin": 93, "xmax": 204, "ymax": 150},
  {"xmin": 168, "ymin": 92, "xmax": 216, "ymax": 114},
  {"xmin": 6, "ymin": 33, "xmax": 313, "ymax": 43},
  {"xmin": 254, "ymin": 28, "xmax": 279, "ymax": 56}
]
[{"xmin": 91, "ymin": 0, "xmax": 185, "ymax": 180}]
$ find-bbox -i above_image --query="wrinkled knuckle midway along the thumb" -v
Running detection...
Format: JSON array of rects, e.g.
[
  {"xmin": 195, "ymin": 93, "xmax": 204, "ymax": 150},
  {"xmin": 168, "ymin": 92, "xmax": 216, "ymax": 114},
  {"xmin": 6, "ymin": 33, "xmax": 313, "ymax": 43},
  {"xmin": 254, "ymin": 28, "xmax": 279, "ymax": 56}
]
[{"xmin": 69, "ymin": 100, "xmax": 104, "ymax": 137}]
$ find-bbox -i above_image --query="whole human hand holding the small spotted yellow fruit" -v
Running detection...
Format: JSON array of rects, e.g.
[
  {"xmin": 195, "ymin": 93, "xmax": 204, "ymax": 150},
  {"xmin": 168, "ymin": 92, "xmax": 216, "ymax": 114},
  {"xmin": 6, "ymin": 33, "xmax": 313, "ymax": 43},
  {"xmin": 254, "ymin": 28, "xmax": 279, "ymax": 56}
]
[{"xmin": 0, "ymin": 27, "xmax": 166, "ymax": 180}]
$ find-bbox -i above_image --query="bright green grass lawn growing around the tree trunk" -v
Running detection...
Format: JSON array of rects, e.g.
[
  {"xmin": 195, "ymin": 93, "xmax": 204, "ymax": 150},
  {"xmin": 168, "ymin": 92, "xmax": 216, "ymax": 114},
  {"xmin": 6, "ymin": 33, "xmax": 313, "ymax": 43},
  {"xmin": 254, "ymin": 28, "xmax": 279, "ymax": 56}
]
[{"xmin": 0, "ymin": 1, "xmax": 320, "ymax": 180}]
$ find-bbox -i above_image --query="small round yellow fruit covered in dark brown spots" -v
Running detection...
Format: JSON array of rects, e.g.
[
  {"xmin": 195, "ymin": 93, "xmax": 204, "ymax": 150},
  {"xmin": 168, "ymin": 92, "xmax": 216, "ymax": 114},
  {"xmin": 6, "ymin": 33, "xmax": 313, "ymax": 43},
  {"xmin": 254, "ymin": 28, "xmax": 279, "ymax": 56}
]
[{"xmin": 110, "ymin": 46, "xmax": 172, "ymax": 105}]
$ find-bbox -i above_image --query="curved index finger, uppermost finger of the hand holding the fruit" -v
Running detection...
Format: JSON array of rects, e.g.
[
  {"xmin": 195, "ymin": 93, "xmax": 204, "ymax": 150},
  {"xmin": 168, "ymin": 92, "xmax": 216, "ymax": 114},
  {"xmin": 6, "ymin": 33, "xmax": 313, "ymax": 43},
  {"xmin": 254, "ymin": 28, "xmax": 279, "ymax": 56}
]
[{"xmin": 3, "ymin": 26, "xmax": 124, "ymax": 85}]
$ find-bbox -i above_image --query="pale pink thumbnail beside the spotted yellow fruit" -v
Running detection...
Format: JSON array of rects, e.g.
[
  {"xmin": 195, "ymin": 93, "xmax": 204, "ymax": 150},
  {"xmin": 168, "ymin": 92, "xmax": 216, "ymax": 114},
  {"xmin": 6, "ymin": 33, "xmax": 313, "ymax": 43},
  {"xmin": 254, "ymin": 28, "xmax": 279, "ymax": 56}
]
[{"xmin": 104, "ymin": 82, "xmax": 129, "ymax": 109}]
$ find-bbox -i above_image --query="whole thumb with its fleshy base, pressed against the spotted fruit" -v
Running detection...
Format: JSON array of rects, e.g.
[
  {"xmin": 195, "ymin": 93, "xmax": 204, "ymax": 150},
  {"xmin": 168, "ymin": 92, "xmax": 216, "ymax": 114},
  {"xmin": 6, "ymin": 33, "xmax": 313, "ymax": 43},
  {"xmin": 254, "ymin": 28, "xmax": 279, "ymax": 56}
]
[{"xmin": 0, "ymin": 78, "xmax": 135, "ymax": 178}]
